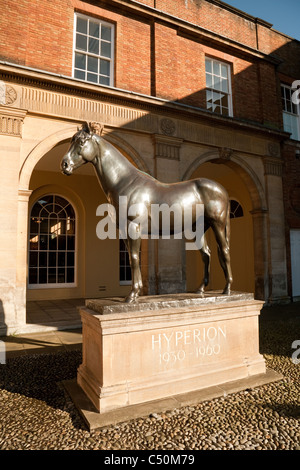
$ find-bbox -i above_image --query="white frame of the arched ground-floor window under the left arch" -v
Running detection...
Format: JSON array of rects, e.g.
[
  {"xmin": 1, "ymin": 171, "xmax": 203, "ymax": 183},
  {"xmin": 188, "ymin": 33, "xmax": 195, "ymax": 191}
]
[{"xmin": 27, "ymin": 193, "xmax": 78, "ymax": 290}]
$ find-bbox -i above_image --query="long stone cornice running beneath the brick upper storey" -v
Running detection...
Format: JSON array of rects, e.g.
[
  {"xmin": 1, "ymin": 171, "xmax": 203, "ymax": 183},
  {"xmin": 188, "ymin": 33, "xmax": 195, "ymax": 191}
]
[{"xmin": 0, "ymin": 61, "xmax": 289, "ymax": 141}]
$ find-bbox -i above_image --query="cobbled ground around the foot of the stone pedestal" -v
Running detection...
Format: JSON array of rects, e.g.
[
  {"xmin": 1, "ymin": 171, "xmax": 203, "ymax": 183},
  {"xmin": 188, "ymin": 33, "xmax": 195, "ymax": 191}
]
[{"xmin": 0, "ymin": 304, "xmax": 300, "ymax": 450}]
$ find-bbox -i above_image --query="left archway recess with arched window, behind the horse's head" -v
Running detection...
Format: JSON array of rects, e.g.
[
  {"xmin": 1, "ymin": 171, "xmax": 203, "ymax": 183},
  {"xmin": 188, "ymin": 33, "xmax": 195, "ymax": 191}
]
[{"xmin": 20, "ymin": 127, "xmax": 148, "ymax": 326}]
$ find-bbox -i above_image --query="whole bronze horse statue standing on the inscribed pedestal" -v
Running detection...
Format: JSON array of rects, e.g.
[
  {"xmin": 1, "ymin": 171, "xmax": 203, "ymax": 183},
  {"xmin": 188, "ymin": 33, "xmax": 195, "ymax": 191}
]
[{"xmin": 61, "ymin": 123, "xmax": 233, "ymax": 302}]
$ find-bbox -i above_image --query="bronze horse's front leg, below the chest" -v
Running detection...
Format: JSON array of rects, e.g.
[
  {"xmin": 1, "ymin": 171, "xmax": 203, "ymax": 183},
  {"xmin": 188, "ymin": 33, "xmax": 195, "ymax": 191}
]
[{"xmin": 124, "ymin": 229, "xmax": 143, "ymax": 303}]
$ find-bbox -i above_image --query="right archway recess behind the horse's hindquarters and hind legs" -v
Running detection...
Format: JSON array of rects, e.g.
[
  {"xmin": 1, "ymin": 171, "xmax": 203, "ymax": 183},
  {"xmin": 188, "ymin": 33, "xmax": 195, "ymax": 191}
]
[{"xmin": 184, "ymin": 153, "xmax": 267, "ymax": 299}]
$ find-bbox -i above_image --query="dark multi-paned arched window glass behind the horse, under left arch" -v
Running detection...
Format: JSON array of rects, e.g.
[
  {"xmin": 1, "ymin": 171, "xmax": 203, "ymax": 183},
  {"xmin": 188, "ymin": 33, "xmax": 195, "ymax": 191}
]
[{"xmin": 28, "ymin": 195, "xmax": 76, "ymax": 287}]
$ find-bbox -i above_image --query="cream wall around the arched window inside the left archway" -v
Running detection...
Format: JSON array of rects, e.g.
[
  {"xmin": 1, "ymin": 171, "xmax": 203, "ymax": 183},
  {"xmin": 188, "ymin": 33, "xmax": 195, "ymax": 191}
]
[{"xmin": 27, "ymin": 170, "xmax": 129, "ymax": 300}]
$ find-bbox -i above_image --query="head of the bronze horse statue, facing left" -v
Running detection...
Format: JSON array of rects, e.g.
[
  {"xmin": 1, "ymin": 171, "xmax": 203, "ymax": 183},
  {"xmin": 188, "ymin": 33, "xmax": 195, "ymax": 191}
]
[{"xmin": 61, "ymin": 122, "xmax": 103, "ymax": 175}]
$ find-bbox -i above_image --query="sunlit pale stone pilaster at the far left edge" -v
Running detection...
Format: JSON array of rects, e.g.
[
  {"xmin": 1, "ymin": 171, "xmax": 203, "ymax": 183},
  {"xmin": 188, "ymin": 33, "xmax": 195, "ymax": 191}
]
[{"xmin": 0, "ymin": 106, "xmax": 27, "ymax": 335}]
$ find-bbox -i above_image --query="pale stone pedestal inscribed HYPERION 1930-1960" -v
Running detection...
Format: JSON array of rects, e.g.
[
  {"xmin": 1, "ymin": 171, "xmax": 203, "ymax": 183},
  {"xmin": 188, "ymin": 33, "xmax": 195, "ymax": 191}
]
[{"xmin": 77, "ymin": 293, "xmax": 266, "ymax": 414}]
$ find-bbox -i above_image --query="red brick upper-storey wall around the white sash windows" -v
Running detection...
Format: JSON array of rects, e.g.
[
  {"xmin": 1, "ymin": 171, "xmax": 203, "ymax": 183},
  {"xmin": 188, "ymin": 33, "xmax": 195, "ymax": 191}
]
[{"xmin": 0, "ymin": 0, "xmax": 300, "ymax": 127}]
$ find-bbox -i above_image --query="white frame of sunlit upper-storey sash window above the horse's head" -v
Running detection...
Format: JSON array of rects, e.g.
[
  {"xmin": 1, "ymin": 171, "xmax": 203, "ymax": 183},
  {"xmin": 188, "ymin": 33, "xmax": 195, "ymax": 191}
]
[{"xmin": 72, "ymin": 13, "xmax": 115, "ymax": 87}]
